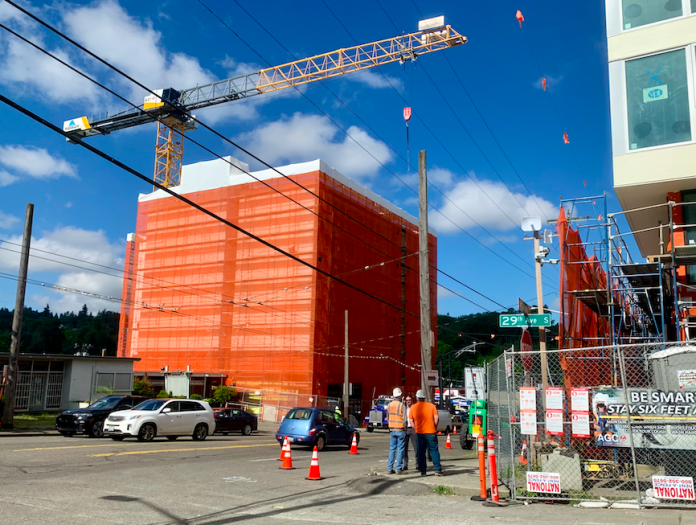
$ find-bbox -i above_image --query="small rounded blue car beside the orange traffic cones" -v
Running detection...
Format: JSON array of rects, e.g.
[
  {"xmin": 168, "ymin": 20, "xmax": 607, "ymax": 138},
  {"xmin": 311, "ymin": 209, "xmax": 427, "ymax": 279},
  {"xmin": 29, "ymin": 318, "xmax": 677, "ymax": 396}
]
[{"xmin": 276, "ymin": 407, "xmax": 360, "ymax": 450}]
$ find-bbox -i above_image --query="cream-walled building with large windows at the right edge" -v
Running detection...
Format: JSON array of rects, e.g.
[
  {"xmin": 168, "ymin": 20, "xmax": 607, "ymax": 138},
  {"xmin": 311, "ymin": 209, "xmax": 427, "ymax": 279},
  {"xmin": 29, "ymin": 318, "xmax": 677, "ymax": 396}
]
[{"xmin": 606, "ymin": 0, "xmax": 696, "ymax": 339}]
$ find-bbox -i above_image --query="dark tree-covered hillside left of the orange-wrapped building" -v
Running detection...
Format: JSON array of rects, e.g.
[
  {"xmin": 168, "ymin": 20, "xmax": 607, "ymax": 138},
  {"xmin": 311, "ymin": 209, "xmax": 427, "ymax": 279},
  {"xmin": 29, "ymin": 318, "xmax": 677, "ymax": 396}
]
[{"xmin": 0, "ymin": 305, "xmax": 120, "ymax": 356}]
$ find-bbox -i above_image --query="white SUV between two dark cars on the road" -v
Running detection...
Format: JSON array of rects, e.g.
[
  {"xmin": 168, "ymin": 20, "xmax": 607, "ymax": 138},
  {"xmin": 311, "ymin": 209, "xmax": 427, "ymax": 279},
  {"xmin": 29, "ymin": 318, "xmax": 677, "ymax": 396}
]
[{"xmin": 104, "ymin": 399, "xmax": 215, "ymax": 441}]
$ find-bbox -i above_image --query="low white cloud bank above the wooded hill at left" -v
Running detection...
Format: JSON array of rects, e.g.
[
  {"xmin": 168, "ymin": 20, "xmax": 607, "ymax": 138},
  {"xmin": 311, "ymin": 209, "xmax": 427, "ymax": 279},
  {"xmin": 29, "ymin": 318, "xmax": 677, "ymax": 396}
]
[{"xmin": 0, "ymin": 225, "xmax": 124, "ymax": 312}]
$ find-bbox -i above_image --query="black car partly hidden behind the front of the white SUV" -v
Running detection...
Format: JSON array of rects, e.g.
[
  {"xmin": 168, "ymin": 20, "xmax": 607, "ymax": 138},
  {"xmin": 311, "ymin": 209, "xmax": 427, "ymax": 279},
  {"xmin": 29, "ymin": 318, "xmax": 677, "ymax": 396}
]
[{"xmin": 56, "ymin": 396, "xmax": 147, "ymax": 437}]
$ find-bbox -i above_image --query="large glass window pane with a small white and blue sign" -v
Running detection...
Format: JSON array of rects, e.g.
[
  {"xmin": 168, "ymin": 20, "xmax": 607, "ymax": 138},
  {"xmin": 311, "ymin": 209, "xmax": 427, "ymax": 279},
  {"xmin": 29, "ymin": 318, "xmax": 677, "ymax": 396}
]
[{"xmin": 626, "ymin": 49, "xmax": 691, "ymax": 150}]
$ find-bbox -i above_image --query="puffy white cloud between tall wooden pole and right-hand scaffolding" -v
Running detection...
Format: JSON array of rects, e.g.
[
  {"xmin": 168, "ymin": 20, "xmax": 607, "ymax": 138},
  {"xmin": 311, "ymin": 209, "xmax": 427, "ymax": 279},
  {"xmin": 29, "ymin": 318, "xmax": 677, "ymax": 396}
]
[{"xmin": 430, "ymin": 180, "xmax": 557, "ymax": 233}]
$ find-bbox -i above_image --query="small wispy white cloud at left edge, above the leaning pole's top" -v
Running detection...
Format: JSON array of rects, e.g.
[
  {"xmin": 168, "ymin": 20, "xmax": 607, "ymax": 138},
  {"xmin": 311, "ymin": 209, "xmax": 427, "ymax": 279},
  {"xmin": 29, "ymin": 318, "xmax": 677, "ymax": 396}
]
[{"xmin": 0, "ymin": 146, "xmax": 77, "ymax": 181}]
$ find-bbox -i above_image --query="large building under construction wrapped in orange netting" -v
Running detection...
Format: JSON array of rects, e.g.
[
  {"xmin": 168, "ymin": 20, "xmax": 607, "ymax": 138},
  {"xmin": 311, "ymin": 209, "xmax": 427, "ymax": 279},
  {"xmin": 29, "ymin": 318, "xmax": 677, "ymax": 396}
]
[{"xmin": 118, "ymin": 157, "xmax": 437, "ymax": 412}]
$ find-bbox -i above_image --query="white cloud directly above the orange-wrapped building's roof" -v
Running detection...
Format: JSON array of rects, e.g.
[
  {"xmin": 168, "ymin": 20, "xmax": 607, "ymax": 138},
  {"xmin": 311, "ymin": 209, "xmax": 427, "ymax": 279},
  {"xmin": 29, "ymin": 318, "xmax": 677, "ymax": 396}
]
[{"xmin": 235, "ymin": 113, "xmax": 392, "ymax": 178}]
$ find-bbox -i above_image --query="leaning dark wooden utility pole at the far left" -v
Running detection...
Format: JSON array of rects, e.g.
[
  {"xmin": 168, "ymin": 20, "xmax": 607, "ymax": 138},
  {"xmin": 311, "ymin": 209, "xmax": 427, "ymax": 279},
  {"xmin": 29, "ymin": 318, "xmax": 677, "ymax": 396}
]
[{"xmin": 2, "ymin": 203, "xmax": 34, "ymax": 429}]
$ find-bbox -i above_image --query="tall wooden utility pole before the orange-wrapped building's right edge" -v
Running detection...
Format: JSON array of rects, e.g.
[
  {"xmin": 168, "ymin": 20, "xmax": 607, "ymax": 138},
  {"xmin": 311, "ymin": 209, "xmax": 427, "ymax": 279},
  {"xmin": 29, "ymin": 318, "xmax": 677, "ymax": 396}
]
[{"xmin": 418, "ymin": 150, "xmax": 433, "ymax": 403}]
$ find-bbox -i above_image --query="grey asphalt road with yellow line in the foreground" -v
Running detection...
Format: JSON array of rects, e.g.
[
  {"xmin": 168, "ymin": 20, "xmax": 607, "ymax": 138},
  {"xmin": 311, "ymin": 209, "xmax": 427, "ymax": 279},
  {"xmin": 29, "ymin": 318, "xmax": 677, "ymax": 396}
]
[{"xmin": 0, "ymin": 427, "xmax": 696, "ymax": 525}]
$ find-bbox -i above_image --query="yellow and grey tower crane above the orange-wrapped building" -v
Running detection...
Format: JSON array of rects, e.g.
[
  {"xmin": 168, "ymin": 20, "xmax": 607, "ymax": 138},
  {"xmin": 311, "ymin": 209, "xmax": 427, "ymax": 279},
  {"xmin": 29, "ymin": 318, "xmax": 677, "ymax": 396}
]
[{"xmin": 63, "ymin": 16, "xmax": 467, "ymax": 187}]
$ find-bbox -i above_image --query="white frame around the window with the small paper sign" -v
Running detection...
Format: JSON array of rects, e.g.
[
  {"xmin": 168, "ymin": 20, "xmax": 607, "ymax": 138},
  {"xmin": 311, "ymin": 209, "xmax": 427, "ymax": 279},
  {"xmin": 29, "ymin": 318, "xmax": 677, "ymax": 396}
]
[{"xmin": 624, "ymin": 43, "xmax": 696, "ymax": 155}]
